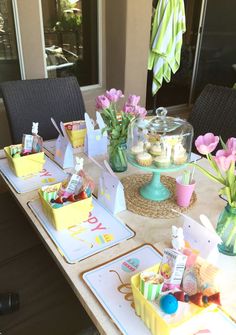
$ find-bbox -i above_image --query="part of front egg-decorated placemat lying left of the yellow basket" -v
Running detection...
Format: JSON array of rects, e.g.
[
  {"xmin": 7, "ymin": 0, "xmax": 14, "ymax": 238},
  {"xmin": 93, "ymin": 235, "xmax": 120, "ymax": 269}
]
[{"xmin": 83, "ymin": 245, "xmax": 162, "ymax": 335}]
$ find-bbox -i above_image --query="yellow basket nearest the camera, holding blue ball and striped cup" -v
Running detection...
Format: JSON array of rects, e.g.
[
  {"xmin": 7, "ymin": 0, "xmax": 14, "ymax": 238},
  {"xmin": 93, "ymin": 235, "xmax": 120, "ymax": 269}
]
[{"xmin": 131, "ymin": 264, "xmax": 216, "ymax": 335}]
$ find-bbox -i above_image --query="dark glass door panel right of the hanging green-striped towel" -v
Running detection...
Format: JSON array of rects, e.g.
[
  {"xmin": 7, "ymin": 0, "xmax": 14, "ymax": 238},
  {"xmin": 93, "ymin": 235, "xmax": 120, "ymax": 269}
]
[{"xmin": 192, "ymin": 0, "xmax": 236, "ymax": 101}]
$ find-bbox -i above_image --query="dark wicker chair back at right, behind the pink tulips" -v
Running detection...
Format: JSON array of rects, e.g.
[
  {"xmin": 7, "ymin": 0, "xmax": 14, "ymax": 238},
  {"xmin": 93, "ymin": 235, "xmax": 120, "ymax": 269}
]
[{"xmin": 188, "ymin": 84, "xmax": 236, "ymax": 149}]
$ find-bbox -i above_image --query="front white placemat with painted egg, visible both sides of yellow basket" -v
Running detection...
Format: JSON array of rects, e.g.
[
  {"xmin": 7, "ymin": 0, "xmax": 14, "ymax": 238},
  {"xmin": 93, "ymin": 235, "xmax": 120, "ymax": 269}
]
[{"xmin": 83, "ymin": 245, "xmax": 236, "ymax": 335}]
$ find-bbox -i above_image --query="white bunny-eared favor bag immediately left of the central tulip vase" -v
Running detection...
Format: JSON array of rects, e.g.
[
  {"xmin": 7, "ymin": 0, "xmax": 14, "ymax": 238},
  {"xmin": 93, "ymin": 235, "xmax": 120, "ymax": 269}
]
[{"xmin": 84, "ymin": 112, "xmax": 107, "ymax": 157}]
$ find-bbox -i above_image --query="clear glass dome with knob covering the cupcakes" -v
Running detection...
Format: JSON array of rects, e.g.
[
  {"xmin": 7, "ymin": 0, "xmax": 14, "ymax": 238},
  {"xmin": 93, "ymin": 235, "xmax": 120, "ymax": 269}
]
[{"xmin": 127, "ymin": 107, "xmax": 193, "ymax": 172}]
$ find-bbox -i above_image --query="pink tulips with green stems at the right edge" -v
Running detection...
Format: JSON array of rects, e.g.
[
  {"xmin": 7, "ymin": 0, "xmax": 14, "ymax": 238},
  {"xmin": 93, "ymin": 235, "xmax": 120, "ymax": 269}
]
[{"xmin": 195, "ymin": 133, "xmax": 236, "ymax": 208}]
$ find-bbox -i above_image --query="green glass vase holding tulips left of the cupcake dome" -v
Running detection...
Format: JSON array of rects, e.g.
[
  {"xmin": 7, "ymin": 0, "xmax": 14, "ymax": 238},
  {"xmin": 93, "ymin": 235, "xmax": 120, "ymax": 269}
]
[{"xmin": 108, "ymin": 142, "xmax": 128, "ymax": 172}]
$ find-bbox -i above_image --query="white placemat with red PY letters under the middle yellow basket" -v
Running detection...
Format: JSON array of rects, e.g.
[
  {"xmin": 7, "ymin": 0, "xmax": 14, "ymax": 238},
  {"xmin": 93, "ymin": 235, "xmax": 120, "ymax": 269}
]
[{"xmin": 29, "ymin": 198, "xmax": 134, "ymax": 263}]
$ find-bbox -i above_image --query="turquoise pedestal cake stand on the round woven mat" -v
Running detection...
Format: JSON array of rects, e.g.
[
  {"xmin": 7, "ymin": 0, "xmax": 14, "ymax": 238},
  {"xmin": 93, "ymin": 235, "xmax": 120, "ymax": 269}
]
[{"xmin": 127, "ymin": 155, "xmax": 188, "ymax": 202}]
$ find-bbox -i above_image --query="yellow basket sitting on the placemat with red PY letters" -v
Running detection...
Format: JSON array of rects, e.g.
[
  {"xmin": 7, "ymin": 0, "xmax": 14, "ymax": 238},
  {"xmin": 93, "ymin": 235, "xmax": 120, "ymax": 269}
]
[{"xmin": 39, "ymin": 183, "xmax": 93, "ymax": 230}]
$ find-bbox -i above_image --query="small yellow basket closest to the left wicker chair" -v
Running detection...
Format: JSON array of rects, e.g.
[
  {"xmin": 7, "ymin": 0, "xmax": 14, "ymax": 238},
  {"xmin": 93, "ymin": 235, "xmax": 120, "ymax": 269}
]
[{"xmin": 4, "ymin": 145, "xmax": 45, "ymax": 177}]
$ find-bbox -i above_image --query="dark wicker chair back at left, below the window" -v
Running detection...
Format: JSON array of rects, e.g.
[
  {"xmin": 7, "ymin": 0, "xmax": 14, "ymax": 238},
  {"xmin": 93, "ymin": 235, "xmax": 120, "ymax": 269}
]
[{"xmin": 1, "ymin": 77, "xmax": 85, "ymax": 144}]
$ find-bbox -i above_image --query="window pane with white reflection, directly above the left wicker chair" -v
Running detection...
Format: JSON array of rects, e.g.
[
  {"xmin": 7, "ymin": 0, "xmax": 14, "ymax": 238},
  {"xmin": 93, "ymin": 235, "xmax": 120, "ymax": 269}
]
[{"xmin": 42, "ymin": 0, "xmax": 98, "ymax": 86}]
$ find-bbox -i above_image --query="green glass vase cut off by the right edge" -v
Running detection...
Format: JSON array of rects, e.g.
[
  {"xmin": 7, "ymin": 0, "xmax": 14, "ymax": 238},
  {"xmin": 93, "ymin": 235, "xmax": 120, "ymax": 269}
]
[{"xmin": 216, "ymin": 204, "xmax": 236, "ymax": 256}]
